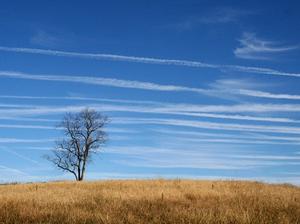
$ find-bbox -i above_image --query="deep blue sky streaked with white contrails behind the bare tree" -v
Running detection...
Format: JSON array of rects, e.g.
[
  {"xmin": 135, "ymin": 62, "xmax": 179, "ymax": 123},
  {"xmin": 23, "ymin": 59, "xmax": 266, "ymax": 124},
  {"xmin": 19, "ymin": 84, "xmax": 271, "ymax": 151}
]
[{"xmin": 0, "ymin": 1, "xmax": 300, "ymax": 184}]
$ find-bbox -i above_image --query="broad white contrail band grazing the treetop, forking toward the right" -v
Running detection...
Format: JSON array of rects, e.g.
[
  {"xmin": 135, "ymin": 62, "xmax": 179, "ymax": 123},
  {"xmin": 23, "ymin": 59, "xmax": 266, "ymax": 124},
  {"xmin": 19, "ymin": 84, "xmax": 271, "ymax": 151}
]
[{"xmin": 0, "ymin": 102, "xmax": 300, "ymax": 123}]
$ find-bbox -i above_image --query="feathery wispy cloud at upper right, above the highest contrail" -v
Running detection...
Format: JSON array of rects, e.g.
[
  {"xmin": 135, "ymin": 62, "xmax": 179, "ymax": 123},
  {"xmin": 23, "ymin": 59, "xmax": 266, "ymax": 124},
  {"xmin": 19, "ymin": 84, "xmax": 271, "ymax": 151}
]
[{"xmin": 234, "ymin": 33, "xmax": 299, "ymax": 60}]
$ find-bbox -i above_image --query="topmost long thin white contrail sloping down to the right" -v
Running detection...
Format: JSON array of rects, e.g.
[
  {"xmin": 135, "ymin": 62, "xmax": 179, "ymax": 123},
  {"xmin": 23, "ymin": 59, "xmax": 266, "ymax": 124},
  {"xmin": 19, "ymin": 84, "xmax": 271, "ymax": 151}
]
[{"xmin": 0, "ymin": 46, "xmax": 300, "ymax": 77}]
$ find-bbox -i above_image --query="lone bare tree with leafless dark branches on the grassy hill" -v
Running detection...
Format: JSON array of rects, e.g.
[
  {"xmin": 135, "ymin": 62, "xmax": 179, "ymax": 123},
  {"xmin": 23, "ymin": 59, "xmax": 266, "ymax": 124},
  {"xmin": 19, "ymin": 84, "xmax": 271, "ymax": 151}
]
[{"xmin": 47, "ymin": 108, "xmax": 108, "ymax": 181}]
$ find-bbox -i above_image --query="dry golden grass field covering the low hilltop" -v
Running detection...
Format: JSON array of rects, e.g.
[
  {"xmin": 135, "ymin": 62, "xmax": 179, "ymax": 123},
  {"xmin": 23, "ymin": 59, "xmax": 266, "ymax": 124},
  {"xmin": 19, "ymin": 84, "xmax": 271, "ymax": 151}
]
[{"xmin": 0, "ymin": 180, "xmax": 300, "ymax": 224}]
